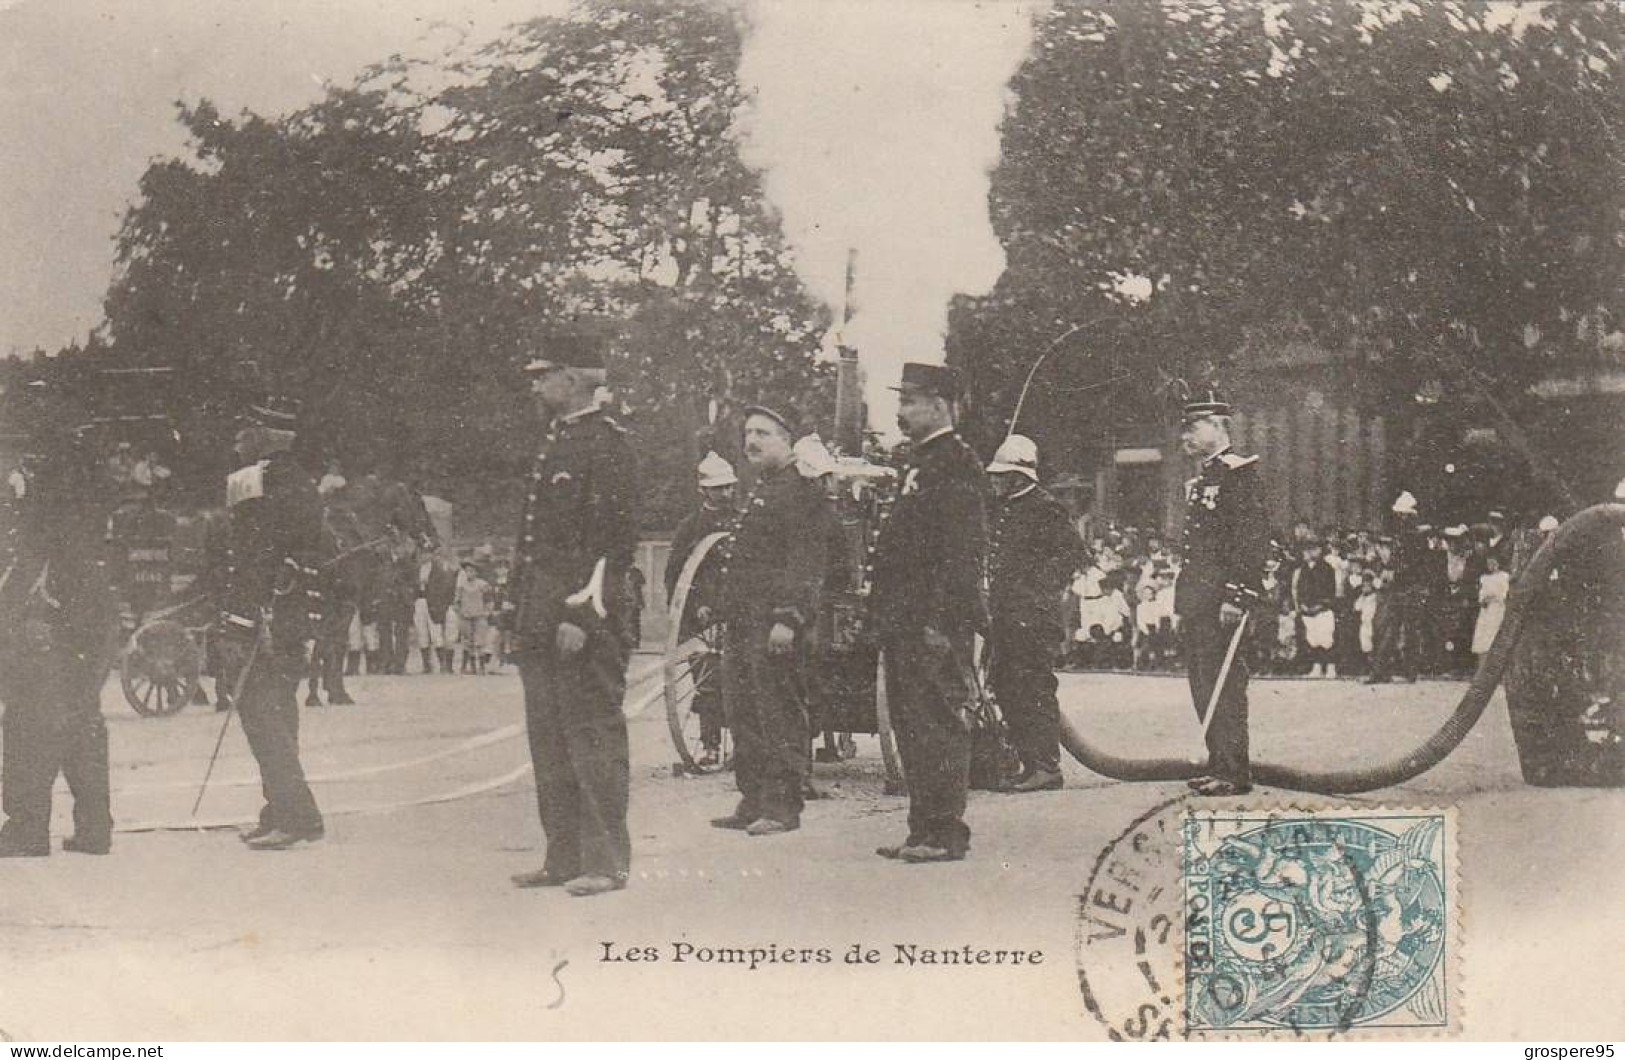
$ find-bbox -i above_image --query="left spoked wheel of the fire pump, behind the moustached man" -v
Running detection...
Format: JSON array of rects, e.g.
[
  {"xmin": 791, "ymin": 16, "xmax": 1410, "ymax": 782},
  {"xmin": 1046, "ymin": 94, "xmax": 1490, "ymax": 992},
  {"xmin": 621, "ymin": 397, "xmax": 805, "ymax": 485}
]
[{"xmin": 663, "ymin": 533, "xmax": 733, "ymax": 772}]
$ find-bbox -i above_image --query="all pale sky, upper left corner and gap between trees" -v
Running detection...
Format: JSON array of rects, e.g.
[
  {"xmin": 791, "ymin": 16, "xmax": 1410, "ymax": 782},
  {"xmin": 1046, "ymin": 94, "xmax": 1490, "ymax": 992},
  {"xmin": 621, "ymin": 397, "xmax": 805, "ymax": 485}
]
[{"xmin": 0, "ymin": 0, "xmax": 1032, "ymax": 431}]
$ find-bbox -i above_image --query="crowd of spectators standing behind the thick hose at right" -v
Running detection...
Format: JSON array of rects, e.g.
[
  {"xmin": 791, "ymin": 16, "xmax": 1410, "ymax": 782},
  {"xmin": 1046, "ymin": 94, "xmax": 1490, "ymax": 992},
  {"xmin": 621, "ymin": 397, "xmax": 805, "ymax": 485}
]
[{"xmin": 1066, "ymin": 512, "xmax": 1555, "ymax": 678}]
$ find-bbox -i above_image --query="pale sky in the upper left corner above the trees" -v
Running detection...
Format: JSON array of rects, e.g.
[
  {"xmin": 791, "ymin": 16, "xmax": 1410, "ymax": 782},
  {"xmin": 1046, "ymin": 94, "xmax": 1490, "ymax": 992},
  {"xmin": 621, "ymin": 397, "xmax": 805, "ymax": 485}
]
[{"xmin": 0, "ymin": 0, "xmax": 566, "ymax": 354}]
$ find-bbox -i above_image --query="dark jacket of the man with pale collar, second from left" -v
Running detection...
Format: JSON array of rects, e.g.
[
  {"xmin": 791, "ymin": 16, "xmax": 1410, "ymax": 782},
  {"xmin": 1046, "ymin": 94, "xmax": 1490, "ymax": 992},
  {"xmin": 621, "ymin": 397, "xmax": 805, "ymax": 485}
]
[{"xmin": 198, "ymin": 454, "xmax": 330, "ymax": 654}]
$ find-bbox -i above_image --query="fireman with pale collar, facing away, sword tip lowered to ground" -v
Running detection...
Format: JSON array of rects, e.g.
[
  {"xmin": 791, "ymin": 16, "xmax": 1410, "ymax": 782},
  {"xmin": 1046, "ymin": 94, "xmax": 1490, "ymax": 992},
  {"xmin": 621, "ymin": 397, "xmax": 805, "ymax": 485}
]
[{"xmin": 198, "ymin": 395, "xmax": 327, "ymax": 850}]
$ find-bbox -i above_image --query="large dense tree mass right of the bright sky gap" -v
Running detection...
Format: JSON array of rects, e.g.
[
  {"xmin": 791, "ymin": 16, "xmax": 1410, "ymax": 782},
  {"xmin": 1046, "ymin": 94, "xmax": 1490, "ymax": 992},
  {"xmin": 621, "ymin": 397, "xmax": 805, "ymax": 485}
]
[{"xmin": 951, "ymin": 0, "xmax": 1625, "ymax": 513}]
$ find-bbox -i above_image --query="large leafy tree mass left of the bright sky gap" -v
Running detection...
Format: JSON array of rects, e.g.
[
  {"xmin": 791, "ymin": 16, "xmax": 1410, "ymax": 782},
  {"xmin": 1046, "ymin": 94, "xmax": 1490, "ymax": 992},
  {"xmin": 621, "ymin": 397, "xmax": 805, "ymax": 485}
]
[{"xmin": 107, "ymin": 0, "xmax": 827, "ymax": 525}]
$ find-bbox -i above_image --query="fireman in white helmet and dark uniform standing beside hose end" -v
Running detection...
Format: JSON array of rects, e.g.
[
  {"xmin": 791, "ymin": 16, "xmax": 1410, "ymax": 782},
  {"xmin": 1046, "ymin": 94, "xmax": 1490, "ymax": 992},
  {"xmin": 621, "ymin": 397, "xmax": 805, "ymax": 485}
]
[{"xmin": 986, "ymin": 434, "xmax": 1082, "ymax": 792}]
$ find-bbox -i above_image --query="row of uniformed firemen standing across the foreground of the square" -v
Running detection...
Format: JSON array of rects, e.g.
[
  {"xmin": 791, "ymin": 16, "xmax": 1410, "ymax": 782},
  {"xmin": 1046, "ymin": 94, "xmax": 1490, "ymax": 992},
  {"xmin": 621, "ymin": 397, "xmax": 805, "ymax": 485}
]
[{"xmin": 0, "ymin": 346, "xmax": 1287, "ymax": 896}]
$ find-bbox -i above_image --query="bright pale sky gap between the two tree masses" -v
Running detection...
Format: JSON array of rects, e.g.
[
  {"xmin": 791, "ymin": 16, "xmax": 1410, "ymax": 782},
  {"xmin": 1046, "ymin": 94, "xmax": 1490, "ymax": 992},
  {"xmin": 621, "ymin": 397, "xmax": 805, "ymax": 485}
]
[{"xmin": 739, "ymin": 0, "xmax": 1032, "ymax": 436}]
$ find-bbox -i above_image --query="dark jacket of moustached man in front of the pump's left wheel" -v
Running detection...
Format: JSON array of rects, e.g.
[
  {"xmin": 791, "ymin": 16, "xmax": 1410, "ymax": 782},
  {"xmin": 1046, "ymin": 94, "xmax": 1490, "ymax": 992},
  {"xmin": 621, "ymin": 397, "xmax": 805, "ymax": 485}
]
[{"xmin": 722, "ymin": 463, "xmax": 834, "ymax": 629}]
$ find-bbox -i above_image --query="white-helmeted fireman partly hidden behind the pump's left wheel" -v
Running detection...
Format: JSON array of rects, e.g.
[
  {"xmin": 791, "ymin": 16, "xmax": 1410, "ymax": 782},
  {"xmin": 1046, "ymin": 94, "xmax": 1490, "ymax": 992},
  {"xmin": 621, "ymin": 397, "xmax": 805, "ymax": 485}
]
[{"xmin": 666, "ymin": 452, "xmax": 739, "ymax": 769}]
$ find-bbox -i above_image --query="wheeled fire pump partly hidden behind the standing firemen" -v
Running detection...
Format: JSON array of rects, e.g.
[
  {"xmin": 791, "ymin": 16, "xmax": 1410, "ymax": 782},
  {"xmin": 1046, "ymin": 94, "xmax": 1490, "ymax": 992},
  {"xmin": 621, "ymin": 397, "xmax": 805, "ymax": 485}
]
[{"xmin": 663, "ymin": 460, "xmax": 902, "ymax": 790}]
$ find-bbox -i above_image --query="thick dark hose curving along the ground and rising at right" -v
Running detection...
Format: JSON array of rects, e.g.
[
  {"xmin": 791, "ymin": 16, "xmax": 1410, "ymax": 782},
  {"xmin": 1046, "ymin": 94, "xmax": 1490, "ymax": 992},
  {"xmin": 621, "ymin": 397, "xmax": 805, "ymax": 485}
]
[{"xmin": 1061, "ymin": 504, "xmax": 1625, "ymax": 795}]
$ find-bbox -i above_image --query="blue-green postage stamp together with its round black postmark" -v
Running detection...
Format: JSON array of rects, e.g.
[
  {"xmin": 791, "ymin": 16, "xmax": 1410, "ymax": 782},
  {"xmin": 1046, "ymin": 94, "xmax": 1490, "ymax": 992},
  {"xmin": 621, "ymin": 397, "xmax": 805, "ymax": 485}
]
[{"xmin": 1077, "ymin": 797, "xmax": 1448, "ymax": 1040}]
